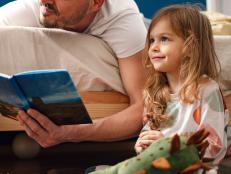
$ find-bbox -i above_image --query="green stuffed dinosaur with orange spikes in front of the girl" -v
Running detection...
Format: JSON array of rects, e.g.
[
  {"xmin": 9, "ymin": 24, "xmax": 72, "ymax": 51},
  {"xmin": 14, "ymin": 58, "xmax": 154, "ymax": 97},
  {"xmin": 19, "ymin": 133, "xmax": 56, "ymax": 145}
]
[{"xmin": 91, "ymin": 129, "xmax": 210, "ymax": 174}]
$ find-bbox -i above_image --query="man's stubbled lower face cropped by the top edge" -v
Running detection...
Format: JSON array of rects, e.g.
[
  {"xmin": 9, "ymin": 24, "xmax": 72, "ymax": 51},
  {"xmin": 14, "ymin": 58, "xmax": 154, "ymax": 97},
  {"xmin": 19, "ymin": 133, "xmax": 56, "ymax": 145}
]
[{"xmin": 39, "ymin": 0, "xmax": 90, "ymax": 30}]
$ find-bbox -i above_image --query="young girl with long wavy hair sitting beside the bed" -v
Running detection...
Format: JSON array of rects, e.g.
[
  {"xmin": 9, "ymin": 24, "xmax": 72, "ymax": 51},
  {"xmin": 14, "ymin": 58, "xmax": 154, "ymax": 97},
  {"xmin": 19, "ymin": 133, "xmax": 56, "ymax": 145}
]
[{"xmin": 135, "ymin": 5, "xmax": 228, "ymax": 162}]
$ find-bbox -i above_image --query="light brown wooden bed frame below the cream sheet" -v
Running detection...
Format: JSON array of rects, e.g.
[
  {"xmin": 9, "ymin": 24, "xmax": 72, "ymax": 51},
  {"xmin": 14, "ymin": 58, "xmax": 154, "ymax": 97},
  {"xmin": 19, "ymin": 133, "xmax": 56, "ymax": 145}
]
[{"xmin": 0, "ymin": 91, "xmax": 231, "ymax": 131}]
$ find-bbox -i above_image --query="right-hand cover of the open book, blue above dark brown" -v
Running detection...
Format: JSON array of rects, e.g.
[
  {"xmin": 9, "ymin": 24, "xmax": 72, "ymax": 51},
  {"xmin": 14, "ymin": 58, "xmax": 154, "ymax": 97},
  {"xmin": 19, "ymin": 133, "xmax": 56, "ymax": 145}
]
[{"xmin": 14, "ymin": 70, "xmax": 92, "ymax": 125}]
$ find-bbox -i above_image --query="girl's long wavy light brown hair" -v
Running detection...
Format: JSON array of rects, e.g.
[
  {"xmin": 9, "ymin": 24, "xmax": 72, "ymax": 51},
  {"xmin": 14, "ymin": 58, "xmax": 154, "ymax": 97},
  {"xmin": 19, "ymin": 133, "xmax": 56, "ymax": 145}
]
[{"xmin": 143, "ymin": 5, "xmax": 220, "ymax": 129}]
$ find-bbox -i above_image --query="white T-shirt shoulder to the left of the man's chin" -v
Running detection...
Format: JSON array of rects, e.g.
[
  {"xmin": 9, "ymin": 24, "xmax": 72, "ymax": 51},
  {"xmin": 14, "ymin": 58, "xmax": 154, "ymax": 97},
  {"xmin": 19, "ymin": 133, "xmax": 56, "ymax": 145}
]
[{"xmin": 0, "ymin": 0, "xmax": 41, "ymax": 27}]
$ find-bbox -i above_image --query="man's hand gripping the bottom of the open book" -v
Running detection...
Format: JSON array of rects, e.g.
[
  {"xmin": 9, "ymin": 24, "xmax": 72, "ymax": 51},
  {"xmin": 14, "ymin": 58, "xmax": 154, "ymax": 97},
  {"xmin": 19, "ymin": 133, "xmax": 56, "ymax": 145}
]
[{"xmin": 17, "ymin": 109, "xmax": 65, "ymax": 147}]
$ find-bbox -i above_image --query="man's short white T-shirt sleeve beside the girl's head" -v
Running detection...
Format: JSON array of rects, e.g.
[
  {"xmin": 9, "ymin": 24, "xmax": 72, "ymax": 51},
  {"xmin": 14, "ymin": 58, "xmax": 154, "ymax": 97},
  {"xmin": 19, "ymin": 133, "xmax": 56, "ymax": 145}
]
[{"xmin": 102, "ymin": 13, "xmax": 147, "ymax": 58}]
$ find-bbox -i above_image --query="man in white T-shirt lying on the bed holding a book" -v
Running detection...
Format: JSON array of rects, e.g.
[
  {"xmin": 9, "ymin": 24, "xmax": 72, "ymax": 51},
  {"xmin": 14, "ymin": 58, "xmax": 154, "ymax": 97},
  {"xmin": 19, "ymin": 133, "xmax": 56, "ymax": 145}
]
[{"xmin": 0, "ymin": 0, "xmax": 146, "ymax": 147}]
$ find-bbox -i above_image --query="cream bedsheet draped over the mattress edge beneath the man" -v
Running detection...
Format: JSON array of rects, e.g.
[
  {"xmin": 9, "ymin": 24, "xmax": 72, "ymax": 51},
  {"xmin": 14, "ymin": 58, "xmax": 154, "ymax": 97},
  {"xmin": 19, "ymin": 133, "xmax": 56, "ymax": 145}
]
[{"xmin": 0, "ymin": 27, "xmax": 125, "ymax": 93}]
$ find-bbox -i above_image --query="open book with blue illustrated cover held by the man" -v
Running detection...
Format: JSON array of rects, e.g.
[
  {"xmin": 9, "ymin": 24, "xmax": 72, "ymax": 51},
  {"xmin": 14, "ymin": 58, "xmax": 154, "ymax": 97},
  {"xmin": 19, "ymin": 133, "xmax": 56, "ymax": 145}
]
[{"xmin": 0, "ymin": 69, "xmax": 92, "ymax": 125}]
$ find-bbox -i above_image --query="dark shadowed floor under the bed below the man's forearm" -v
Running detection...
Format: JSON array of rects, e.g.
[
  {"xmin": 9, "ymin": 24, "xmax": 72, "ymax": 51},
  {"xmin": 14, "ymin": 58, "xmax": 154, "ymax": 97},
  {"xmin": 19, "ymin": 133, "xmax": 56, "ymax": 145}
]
[{"xmin": 0, "ymin": 132, "xmax": 135, "ymax": 174}]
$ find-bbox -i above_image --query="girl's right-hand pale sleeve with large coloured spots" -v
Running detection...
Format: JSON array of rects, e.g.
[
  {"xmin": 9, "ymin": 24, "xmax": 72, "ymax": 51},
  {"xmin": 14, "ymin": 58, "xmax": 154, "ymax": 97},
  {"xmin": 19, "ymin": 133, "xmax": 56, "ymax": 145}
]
[{"xmin": 200, "ymin": 81, "xmax": 228, "ymax": 163}]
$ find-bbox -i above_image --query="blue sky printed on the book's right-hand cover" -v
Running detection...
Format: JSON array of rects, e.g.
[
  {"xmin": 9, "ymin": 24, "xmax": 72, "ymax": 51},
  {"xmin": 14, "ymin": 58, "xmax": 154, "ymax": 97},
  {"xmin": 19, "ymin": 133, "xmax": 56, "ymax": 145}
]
[{"xmin": 16, "ymin": 70, "xmax": 81, "ymax": 104}]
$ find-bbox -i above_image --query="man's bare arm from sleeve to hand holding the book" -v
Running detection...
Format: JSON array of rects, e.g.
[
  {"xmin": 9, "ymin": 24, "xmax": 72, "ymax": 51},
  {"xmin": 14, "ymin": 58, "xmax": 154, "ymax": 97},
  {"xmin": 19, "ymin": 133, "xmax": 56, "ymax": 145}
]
[{"xmin": 17, "ymin": 51, "xmax": 145, "ymax": 147}]
